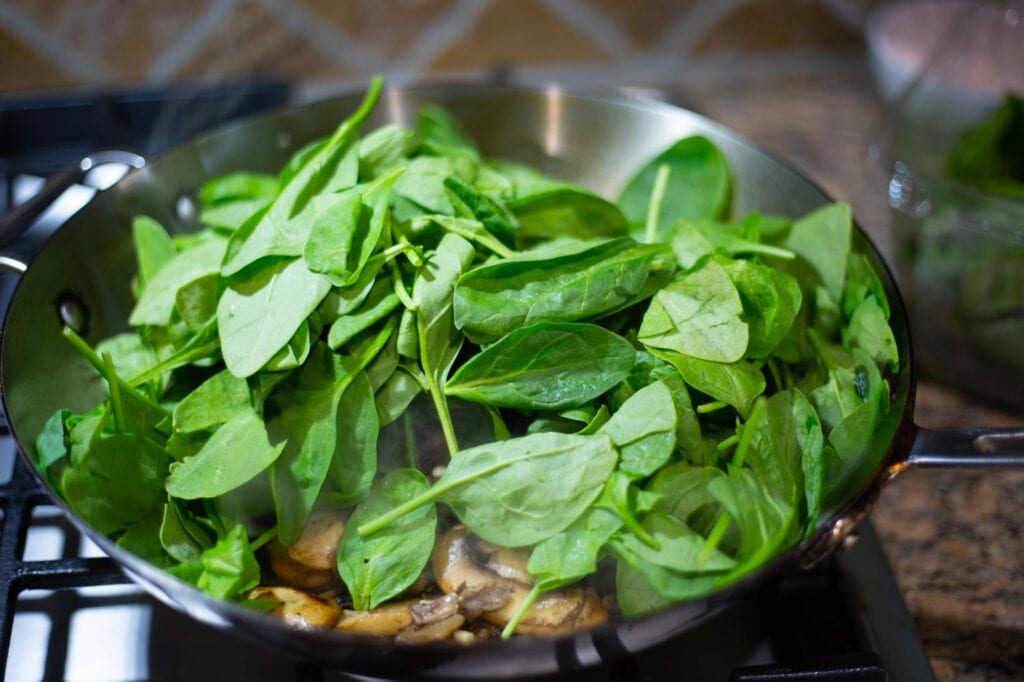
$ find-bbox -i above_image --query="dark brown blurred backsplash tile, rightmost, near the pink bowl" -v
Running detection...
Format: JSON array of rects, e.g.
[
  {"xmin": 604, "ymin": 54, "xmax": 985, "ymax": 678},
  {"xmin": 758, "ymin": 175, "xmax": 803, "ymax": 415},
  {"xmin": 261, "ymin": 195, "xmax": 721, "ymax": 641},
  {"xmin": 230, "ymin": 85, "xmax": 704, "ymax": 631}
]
[{"xmin": 694, "ymin": 0, "xmax": 860, "ymax": 54}]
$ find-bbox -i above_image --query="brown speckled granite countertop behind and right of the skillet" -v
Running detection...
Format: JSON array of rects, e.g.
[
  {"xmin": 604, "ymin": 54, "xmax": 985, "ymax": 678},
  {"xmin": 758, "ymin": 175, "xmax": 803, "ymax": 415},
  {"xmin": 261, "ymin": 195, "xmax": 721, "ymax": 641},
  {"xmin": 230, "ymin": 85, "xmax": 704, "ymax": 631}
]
[{"xmin": 682, "ymin": 62, "xmax": 1024, "ymax": 680}]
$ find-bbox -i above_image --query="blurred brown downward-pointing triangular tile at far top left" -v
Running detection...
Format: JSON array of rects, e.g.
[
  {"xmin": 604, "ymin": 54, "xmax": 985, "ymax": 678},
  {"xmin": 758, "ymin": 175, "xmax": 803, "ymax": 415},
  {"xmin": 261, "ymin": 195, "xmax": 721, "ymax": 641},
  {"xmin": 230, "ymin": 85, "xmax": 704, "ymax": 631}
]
[{"xmin": 12, "ymin": 0, "xmax": 209, "ymax": 82}]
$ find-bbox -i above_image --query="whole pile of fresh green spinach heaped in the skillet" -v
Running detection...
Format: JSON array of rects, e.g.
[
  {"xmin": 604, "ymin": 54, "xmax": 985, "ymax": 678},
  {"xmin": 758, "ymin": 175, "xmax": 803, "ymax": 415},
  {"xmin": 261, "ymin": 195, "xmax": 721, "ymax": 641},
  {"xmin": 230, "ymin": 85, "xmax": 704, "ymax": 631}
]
[{"xmin": 37, "ymin": 82, "xmax": 900, "ymax": 634}]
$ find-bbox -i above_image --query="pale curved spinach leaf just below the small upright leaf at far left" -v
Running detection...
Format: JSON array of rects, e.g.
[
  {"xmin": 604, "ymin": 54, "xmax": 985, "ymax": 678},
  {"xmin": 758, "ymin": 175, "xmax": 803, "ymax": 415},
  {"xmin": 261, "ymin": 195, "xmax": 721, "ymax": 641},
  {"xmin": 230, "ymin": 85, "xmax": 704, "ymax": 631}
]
[{"xmin": 128, "ymin": 239, "xmax": 227, "ymax": 327}]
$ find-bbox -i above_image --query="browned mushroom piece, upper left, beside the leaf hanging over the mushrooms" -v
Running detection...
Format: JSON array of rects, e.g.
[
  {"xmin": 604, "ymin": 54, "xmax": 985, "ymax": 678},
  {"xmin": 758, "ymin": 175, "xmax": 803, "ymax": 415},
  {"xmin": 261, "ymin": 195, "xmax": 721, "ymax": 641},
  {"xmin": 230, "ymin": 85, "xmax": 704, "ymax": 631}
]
[{"xmin": 270, "ymin": 512, "xmax": 345, "ymax": 590}]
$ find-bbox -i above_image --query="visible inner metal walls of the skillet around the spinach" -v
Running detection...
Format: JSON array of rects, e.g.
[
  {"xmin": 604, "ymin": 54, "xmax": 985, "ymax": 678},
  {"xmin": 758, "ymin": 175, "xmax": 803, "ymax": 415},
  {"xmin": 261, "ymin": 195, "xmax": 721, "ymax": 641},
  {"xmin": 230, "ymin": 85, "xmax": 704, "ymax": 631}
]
[{"xmin": 0, "ymin": 86, "xmax": 910, "ymax": 663}]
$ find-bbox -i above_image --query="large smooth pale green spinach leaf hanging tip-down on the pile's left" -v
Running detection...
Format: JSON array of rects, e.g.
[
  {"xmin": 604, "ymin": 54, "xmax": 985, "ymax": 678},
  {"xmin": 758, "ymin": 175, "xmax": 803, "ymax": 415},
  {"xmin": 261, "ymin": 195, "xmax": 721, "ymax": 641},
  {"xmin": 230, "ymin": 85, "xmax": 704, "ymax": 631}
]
[{"xmin": 217, "ymin": 258, "xmax": 331, "ymax": 378}]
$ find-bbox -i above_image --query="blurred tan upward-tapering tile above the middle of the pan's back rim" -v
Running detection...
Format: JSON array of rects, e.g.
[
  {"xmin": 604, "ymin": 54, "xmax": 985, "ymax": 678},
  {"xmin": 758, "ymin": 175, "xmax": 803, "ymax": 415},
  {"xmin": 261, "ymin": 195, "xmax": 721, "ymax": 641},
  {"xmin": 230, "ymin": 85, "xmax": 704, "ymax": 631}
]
[{"xmin": 430, "ymin": 0, "xmax": 606, "ymax": 70}]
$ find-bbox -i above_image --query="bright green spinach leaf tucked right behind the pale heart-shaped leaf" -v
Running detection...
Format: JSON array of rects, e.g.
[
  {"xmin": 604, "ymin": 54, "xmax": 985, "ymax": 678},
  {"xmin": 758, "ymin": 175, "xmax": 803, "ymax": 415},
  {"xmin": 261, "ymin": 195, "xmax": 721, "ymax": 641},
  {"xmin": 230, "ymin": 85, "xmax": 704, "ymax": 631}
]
[{"xmin": 722, "ymin": 260, "xmax": 803, "ymax": 358}]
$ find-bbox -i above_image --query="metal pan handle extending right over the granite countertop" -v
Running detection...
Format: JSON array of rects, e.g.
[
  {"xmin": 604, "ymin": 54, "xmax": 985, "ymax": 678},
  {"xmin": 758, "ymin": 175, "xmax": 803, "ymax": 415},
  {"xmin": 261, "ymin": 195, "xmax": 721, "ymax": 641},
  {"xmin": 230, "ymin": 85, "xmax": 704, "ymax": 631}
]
[{"xmin": 893, "ymin": 427, "xmax": 1024, "ymax": 474}]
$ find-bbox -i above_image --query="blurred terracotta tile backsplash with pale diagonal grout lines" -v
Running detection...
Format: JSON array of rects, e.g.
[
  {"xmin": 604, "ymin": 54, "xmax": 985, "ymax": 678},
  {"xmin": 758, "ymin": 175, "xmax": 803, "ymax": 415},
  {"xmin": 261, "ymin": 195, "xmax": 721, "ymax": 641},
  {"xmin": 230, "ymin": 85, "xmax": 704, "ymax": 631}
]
[{"xmin": 0, "ymin": 0, "xmax": 873, "ymax": 93}]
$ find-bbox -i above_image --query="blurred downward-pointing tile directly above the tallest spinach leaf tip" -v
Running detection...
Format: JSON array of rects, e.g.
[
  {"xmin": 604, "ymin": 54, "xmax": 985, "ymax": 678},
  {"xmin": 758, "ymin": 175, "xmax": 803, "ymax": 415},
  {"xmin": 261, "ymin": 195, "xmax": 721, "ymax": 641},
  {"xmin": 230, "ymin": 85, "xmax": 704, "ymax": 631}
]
[{"xmin": 300, "ymin": 0, "xmax": 455, "ymax": 62}]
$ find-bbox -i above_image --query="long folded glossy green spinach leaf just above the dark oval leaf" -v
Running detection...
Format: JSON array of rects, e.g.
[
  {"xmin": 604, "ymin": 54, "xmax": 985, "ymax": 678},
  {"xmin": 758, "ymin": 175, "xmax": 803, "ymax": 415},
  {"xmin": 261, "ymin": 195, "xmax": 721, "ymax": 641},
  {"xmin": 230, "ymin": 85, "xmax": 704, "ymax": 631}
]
[{"xmin": 455, "ymin": 239, "xmax": 668, "ymax": 343}]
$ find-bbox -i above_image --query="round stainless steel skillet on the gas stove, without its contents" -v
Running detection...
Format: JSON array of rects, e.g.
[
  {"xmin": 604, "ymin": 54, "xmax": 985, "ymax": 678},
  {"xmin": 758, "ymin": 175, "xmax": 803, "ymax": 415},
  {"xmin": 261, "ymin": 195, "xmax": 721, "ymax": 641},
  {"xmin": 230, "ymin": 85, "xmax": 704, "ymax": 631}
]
[{"xmin": 0, "ymin": 86, "xmax": 1024, "ymax": 679}]
